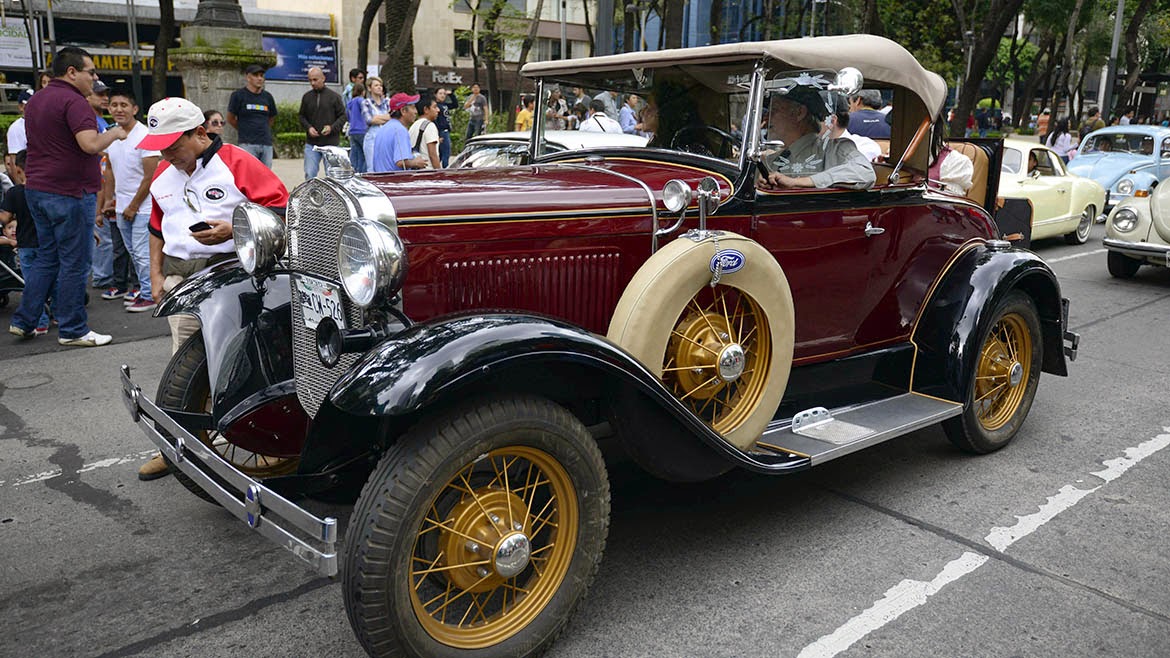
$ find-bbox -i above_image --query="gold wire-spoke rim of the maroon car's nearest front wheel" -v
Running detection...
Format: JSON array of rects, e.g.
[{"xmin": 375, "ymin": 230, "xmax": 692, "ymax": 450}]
[{"xmin": 410, "ymin": 446, "xmax": 579, "ymax": 649}]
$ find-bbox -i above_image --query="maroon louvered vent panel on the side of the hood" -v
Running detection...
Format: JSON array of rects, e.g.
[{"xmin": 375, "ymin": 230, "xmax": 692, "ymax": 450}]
[{"xmin": 443, "ymin": 251, "xmax": 621, "ymax": 334}]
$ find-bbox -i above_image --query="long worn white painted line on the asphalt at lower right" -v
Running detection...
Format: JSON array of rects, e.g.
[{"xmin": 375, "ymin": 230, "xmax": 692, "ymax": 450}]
[{"xmin": 798, "ymin": 428, "xmax": 1170, "ymax": 658}]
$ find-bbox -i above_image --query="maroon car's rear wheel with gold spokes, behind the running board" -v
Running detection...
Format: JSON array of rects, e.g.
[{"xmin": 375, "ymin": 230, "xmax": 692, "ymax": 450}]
[{"xmin": 943, "ymin": 292, "xmax": 1044, "ymax": 454}]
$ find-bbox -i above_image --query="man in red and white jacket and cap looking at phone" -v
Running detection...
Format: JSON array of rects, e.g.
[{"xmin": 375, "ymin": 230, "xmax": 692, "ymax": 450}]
[{"xmin": 138, "ymin": 98, "xmax": 289, "ymax": 480}]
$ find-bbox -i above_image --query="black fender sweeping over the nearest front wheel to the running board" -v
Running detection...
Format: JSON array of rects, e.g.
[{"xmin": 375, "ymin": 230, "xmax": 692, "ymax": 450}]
[{"xmin": 330, "ymin": 314, "xmax": 792, "ymax": 472}]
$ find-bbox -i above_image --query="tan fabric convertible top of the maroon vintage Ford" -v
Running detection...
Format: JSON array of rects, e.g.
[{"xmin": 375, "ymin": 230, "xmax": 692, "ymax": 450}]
[{"xmin": 521, "ymin": 34, "xmax": 947, "ymax": 116}]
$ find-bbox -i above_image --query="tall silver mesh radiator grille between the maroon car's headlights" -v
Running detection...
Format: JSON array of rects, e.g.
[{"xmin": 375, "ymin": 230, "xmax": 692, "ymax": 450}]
[{"xmin": 287, "ymin": 180, "xmax": 363, "ymax": 417}]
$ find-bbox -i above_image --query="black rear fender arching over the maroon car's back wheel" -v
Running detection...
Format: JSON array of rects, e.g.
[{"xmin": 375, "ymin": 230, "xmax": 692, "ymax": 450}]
[{"xmin": 913, "ymin": 246, "xmax": 1068, "ymax": 402}]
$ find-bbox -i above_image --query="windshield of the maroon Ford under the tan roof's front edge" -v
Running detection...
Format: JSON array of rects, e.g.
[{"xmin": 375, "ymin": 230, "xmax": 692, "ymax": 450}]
[{"xmin": 534, "ymin": 62, "xmax": 752, "ymax": 162}]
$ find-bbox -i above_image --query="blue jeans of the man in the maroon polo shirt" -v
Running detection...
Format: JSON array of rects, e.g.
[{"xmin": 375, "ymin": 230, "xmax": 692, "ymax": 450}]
[{"xmin": 12, "ymin": 190, "xmax": 97, "ymax": 338}]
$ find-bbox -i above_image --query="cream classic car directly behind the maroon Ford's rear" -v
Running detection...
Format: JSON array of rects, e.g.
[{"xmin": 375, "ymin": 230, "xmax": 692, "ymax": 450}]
[{"xmin": 999, "ymin": 139, "xmax": 1106, "ymax": 245}]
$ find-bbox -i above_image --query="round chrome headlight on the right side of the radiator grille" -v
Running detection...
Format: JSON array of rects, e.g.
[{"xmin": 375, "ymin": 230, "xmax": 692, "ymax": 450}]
[{"xmin": 337, "ymin": 219, "xmax": 406, "ymax": 309}]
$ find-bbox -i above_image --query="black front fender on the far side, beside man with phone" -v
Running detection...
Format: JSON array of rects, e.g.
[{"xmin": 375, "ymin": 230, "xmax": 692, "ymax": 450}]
[{"xmin": 154, "ymin": 261, "xmax": 293, "ymax": 420}]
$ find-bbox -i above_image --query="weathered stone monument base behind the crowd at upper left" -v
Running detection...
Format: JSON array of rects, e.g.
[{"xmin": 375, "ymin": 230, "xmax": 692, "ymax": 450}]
[{"xmin": 170, "ymin": 0, "xmax": 276, "ymax": 144}]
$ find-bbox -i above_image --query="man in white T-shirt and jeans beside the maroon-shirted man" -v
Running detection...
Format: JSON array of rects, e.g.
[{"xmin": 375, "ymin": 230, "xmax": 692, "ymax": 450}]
[{"xmin": 102, "ymin": 91, "xmax": 161, "ymax": 313}]
